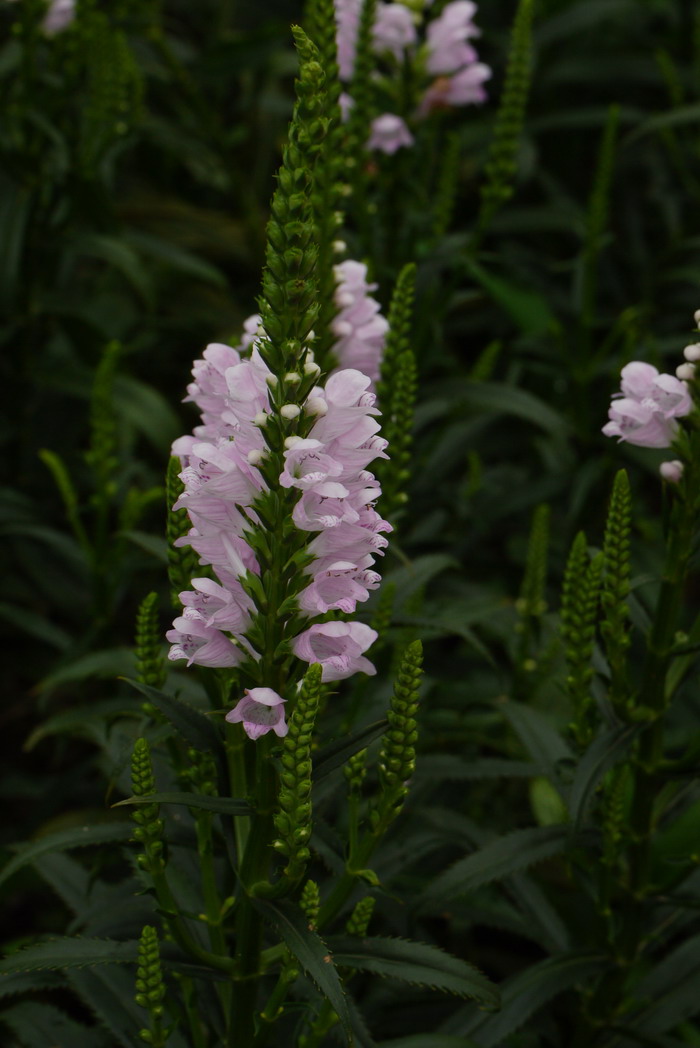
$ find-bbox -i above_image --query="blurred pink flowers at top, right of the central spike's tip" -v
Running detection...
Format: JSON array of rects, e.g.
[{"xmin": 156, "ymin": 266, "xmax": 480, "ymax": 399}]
[{"xmin": 335, "ymin": 0, "xmax": 491, "ymax": 154}]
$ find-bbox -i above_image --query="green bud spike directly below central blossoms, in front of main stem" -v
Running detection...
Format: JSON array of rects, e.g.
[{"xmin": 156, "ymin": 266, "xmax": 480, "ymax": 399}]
[{"xmin": 274, "ymin": 663, "xmax": 322, "ymax": 879}]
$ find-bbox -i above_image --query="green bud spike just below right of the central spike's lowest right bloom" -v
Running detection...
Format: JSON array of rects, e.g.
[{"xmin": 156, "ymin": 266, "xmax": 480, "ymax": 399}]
[{"xmin": 371, "ymin": 640, "xmax": 423, "ymax": 829}]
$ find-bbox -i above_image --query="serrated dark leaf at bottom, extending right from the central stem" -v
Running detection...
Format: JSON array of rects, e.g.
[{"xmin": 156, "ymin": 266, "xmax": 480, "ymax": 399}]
[{"xmin": 328, "ymin": 936, "xmax": 500, "ymax": 1008}]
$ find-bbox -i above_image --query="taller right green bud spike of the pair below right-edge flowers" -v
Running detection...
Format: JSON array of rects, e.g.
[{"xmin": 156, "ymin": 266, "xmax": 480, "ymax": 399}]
[{"xmin": 600, "ymin": 470, "xmax": 632, "ymax": 706}]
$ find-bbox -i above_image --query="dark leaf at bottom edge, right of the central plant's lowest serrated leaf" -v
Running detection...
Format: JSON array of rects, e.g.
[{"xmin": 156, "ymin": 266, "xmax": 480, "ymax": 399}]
[{"xmin": 460, "ymin": 951, "xmax": 609, "ymax": 1048}]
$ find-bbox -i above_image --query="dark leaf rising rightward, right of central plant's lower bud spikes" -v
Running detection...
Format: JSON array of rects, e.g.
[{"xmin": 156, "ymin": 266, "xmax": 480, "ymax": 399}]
[{"xmin": 424, "ymin": 825, "xmax": 569, "ymax": 899}]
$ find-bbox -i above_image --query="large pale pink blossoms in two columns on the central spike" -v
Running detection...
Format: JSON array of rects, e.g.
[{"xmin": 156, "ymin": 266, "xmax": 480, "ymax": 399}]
[{"xmin": 167, "ymin": 331, "xmax": 391, "ymax": 737}]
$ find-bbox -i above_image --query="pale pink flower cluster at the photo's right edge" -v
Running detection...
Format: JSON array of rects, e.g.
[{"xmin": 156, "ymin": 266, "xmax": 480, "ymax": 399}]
[{"xmin": 603, "ymin": 361, "xmax": 693, "ymax": 447}]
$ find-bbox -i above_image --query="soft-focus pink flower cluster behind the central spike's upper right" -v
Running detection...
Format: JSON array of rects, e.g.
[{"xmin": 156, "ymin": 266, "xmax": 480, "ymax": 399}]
[{"xmin": 331, "ymin": 259, "xmax": 389, "ymax": 388}]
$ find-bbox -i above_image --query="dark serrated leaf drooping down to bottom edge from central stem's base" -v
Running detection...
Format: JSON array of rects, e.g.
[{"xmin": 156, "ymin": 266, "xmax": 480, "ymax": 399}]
[{"xmin": 255, "ymin": 899, "xmax": 352, "ymax": 1045}]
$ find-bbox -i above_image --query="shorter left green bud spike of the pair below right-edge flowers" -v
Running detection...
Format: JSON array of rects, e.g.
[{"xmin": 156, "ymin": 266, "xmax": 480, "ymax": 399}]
[{"xmin": 561, "ymin": 531, "xmax": 604, "ymax": 746}]
